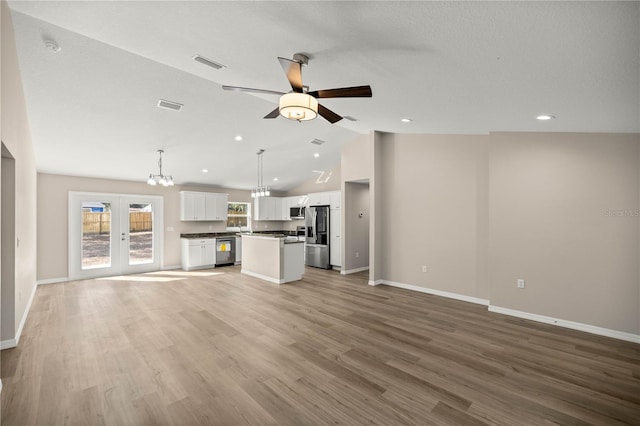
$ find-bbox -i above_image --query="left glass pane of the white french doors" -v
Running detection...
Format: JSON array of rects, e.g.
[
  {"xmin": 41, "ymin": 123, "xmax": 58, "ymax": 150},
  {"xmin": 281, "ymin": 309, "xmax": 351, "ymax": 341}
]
[{"xmin": 81, "ymin": 201, "xmax": 111, "ymax": 269}]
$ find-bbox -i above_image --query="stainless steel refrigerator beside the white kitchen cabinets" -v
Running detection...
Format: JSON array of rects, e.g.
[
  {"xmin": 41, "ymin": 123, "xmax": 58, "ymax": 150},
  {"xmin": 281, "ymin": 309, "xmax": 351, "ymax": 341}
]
[{"xmin": 304, "ymin": 206, "xmax": 331, "ymax": 269}]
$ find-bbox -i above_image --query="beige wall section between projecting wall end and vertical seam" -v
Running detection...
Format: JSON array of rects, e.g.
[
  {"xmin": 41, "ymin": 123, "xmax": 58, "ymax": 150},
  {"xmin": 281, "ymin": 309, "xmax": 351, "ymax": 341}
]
[{"xmin": 376, "ymin": 134, "xmax": 489, "ymax": 300}]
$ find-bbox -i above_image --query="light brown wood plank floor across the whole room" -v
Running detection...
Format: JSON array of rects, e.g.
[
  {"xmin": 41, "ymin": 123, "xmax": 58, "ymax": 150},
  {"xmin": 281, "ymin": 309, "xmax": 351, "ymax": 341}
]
[{"xmin": 2, "ymin": 267, "xmax": 640, "ymax": 426}]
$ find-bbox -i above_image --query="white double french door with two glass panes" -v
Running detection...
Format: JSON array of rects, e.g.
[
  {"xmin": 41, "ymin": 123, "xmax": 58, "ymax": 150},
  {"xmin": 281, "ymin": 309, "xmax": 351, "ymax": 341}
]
[{"xmin": 69, "ymin": 192, "xmax": 163, "ymax": 279}]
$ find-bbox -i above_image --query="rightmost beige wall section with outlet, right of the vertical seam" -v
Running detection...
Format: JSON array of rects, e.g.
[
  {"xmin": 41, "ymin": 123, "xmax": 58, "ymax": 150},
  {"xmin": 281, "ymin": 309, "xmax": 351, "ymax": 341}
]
[{"xmin": 489, "ymin": 133, "xmax": 640, "ymax": 335}]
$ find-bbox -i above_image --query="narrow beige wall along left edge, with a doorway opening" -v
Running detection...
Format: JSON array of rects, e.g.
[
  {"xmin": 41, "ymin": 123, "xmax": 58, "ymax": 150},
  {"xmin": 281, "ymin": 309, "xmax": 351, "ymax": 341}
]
[{"xmin": 0, "ymin": 1, "xmax": 37, "ymax": 341}]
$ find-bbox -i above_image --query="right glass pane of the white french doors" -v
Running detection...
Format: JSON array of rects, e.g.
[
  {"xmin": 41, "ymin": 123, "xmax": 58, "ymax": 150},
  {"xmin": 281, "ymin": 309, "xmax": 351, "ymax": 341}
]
[{"xmin": 129, "ymin": 203, "xmax": 153, "ymax": 265}]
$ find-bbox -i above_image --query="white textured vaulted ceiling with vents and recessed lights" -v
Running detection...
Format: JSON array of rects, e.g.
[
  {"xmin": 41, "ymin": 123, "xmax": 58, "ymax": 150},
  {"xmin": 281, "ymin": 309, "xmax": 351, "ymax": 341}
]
[{"xmin": 9, "ymin": 1, "xmax": 640, "ymax": 190}]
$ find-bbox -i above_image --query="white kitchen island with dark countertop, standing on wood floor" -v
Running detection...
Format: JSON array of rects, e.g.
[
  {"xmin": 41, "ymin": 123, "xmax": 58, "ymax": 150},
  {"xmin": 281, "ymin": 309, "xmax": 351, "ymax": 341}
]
[{"xmin": 241, "ymin": 234, "xmax": 304, "ymax": 284}]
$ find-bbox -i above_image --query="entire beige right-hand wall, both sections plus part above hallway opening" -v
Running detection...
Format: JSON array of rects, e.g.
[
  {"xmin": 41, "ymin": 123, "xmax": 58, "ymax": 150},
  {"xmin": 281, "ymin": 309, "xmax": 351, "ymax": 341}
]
[{"xmin": 342, "ymin": 132, "xmax": 640, "ymax": 335}]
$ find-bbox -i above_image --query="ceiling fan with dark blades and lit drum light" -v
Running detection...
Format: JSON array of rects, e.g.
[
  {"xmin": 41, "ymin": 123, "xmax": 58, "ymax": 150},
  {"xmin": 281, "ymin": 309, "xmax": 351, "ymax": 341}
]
[{"xmin": 222, "ymin": 53, "xmax": 372, "ymax": 123}]
